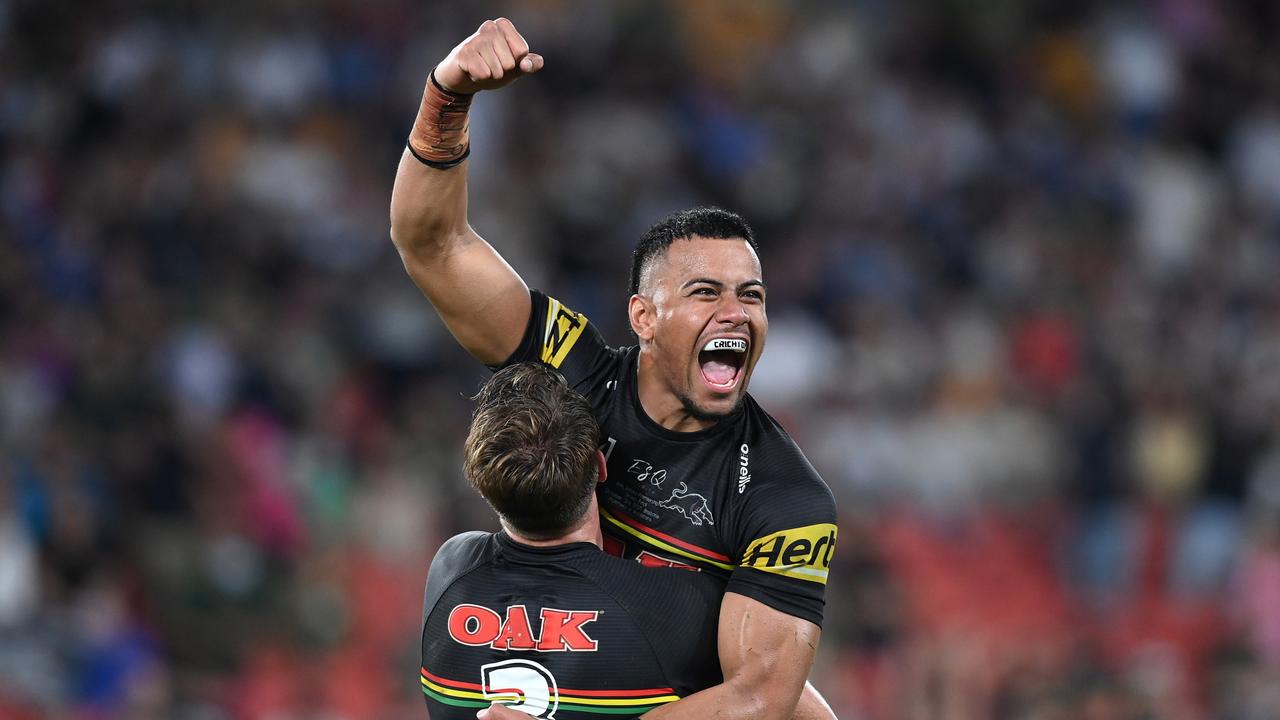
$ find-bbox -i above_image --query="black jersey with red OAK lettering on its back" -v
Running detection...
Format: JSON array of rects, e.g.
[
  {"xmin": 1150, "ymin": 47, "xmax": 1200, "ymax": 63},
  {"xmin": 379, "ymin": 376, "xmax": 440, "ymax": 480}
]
[{"xmin": 421, "ymin": 532, "xmax": 723, "ymax": 720}]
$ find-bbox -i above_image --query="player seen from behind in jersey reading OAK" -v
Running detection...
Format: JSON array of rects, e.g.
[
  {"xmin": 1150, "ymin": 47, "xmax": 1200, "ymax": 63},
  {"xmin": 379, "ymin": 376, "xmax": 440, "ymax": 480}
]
[{"xmin": 421, "ymin": 363, "xmax": 722, "ymax": 720}]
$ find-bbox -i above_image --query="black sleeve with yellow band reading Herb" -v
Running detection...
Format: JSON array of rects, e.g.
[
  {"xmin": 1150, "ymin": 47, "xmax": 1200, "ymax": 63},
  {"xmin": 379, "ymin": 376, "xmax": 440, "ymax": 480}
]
[{"xmin": 726, "ymin": 450, "xmax": 837, "ymax": 628}]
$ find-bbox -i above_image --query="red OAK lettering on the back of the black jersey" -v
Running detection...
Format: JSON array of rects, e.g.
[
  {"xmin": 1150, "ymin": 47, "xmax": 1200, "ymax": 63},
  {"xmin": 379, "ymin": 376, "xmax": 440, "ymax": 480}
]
[{"xmin": 449, "ymin": 603, "xmax": 600, "ymax": 652}]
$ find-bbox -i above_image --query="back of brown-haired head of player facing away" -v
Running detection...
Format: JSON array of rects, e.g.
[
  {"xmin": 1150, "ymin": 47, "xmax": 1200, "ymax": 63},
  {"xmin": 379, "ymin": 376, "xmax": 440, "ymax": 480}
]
[{"xmin": 462, "ymin": 363, "xmax": 600, "ymax": 539}]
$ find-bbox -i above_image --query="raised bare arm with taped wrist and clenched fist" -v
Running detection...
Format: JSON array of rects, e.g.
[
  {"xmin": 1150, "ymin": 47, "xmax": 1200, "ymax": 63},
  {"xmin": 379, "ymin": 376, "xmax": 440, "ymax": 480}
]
[{"xmin": 390, "ymin": 18, "xmax": 543, "ymax": 365}]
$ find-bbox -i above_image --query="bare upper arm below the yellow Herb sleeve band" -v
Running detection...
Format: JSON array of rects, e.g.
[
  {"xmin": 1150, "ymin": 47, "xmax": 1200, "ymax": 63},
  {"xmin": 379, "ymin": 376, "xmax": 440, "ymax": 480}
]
[{"xmin": 718, "ymin": 592, "xmax": 822, "ymax": 717}]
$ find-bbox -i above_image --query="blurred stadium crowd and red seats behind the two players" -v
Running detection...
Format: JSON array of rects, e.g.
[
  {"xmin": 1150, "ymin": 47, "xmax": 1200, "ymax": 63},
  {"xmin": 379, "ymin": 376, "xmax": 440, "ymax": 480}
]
[{"xmin": 0, "ymin": 0, "xmax": 1280, "ymax": 720}]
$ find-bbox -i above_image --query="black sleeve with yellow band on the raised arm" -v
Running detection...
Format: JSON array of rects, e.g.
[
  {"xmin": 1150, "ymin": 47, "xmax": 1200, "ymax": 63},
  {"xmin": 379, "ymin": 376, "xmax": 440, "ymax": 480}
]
[{"xmin": 492, "ymin": 290, "xmax": 612, "ymax": 396}]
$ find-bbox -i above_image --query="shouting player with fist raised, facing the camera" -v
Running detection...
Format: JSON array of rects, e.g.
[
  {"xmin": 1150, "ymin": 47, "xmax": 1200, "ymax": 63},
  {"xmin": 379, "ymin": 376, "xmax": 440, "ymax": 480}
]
[{"xmin": 390, "ymin": 19, "xmax": 836, "ymax": 720}]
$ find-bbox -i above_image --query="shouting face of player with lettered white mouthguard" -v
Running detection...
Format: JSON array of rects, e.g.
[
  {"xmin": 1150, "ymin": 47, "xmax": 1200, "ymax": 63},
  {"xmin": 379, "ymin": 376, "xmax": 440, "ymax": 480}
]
[{"xmin": 641, "ymin": 237, "xmax": 769, "ymax": 420}]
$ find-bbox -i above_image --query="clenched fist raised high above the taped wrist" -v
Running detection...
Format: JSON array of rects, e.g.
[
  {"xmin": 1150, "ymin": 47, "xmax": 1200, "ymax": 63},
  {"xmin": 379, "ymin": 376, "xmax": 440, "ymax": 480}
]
[{"xmin": 435, "ymin": 18, "xmax": 543, "ymax": 94}]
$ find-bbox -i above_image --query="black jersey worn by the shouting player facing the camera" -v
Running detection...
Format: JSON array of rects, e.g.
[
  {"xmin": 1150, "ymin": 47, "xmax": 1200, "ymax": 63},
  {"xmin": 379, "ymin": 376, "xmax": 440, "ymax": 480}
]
[{"xmin": 491, "ymin": 291, "xmax": 836, "ymax": 626}]
